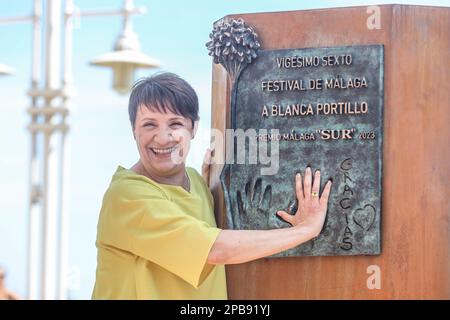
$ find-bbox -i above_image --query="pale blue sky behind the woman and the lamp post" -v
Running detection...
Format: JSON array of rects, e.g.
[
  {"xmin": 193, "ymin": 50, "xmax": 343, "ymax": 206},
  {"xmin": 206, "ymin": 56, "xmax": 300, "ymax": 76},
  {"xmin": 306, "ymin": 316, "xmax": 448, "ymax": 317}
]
[{"xmin": 0, "ymin": 0, "xmax": 450, "ymax": 299}]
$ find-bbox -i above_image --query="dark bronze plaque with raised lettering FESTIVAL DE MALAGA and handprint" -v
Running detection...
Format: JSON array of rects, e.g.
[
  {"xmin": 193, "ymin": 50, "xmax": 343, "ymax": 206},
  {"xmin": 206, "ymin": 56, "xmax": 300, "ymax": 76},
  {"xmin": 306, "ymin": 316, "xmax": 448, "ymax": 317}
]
[{"xmin": 222, "ymin": 45, "xmax": 384, "ymax": 257}]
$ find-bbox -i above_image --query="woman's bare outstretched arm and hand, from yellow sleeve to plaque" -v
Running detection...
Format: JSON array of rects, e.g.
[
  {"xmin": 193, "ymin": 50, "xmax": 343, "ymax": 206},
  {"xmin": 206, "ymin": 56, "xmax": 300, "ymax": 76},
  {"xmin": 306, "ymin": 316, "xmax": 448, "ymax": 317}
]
[{"xmin": 207, "ymin": 167, "xmax": 331, "ymax": 264}]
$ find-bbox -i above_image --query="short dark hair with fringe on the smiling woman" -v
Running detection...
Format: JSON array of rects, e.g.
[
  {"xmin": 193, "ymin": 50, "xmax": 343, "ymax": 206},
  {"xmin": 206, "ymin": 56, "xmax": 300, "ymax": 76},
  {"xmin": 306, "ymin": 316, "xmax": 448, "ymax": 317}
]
[{"xmin": 128, "ymin": 72, "xmax": 199, "ymax": 129}]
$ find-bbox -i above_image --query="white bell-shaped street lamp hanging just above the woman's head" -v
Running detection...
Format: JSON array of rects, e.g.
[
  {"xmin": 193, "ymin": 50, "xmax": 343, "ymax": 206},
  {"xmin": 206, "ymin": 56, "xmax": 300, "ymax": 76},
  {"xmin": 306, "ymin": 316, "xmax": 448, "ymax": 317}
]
[{"xmin": 91, "ymin": 0, "xmax": 159, "ymax": 94}]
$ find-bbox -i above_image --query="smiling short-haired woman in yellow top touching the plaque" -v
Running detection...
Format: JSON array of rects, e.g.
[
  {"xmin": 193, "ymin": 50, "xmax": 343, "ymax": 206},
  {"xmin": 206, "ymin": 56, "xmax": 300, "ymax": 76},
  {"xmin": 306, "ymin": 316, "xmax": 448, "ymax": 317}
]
[{"xmin": 93, "ymin": 73, "xmax": 331, "ymax": 300}]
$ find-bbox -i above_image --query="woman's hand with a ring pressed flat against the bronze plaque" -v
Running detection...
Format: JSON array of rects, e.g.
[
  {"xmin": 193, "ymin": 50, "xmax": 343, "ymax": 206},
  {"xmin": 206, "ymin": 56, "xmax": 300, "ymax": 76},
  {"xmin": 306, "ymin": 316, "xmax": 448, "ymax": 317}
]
[{"xmin": 277, "ymin": 167, "xmax": 331, "ymax": 237}]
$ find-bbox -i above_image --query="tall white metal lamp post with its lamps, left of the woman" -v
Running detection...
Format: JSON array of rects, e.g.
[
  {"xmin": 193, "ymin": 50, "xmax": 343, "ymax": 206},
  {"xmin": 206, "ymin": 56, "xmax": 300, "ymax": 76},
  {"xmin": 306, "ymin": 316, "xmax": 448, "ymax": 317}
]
[{"xmin": 0, "ymin": 0, "xmax": 158, "ymax": 299}]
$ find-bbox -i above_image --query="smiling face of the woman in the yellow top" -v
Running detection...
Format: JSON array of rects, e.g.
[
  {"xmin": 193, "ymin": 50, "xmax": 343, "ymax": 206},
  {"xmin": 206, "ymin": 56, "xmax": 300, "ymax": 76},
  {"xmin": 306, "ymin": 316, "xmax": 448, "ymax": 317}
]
[{"xmin": 133, "ymin": 106, "xmax": 195, "ymax": 177}]
